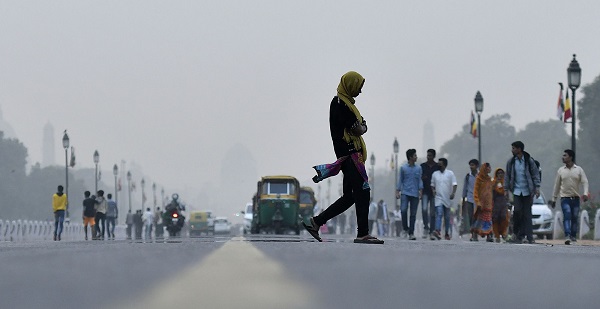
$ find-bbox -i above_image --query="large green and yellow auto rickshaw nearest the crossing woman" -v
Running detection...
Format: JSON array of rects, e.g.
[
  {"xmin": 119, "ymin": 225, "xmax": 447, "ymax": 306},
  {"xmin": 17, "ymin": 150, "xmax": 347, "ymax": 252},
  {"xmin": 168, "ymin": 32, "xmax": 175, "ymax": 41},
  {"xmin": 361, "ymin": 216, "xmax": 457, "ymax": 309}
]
[{"xmin": 250, "ymin": 176, "xmax": 301, "ymax": 235}]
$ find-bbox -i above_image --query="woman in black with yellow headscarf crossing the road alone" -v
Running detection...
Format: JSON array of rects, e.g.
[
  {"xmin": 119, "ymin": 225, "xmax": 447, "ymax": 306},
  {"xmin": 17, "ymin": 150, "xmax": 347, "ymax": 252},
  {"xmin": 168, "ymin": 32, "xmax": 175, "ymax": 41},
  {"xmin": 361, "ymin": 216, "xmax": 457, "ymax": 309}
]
[{"xmin": 302, "ymin": 71, "xmax": 383, "ymax": 244}]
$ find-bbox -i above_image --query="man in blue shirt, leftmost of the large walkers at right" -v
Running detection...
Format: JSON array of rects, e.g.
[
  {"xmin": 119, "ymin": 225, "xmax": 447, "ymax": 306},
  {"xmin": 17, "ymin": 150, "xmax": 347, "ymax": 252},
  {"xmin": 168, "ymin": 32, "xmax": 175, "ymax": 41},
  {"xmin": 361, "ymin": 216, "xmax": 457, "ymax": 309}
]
[{"xmin": 396, "ymin": 149, "xmax": 423, "ymax": 240}]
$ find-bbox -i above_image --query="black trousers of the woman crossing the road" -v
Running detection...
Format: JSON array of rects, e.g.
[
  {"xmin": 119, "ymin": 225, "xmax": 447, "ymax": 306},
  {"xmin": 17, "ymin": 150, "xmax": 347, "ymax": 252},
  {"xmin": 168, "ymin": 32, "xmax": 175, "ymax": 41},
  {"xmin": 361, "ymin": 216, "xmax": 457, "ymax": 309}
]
[{"xmin": 314, "ymin": 158, "xmax": 371, "ymax": 237}]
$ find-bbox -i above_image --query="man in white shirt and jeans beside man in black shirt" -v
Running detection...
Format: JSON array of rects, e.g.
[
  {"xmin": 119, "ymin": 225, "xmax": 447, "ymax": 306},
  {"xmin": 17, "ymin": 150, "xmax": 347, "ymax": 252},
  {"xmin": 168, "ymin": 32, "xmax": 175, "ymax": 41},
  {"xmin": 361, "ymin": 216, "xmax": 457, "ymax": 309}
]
[{"xmin": 431, "ymin": 158, "xmax": 458, "ymax": 240}]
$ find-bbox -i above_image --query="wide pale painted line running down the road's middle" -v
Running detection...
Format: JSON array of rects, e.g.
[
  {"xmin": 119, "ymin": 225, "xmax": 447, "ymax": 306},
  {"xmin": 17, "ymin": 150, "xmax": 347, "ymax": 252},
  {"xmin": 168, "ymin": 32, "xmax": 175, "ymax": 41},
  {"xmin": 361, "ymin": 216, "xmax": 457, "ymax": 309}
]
[{"xmin": 118, "ymin": 237, "xmax": 315, "ymax": 309}]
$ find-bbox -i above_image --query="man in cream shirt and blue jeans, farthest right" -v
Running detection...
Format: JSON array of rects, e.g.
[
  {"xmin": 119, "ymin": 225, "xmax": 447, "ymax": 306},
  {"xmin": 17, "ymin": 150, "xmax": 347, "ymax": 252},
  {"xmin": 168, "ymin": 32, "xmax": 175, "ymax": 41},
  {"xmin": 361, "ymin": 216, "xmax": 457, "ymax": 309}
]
[{"xmin": 551, "ymin": 149, "xmax": 589, "ymax": 245}]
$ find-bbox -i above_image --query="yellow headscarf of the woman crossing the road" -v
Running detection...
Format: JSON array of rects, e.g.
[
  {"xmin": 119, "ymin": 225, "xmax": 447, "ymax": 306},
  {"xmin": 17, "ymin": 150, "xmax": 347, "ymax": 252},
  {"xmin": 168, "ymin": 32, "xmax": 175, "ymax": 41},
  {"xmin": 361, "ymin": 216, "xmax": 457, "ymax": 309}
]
[{"xmin": 337, "ymin": 71, "xmax": 367, "ymax": 163}]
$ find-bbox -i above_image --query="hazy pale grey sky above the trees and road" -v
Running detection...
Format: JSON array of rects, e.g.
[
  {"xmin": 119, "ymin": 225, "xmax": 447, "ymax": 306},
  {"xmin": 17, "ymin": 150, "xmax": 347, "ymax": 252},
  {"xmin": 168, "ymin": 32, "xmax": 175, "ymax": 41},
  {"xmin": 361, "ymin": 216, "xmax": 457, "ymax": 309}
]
[{"xmin": 0, "ymin": 0, "xmax": 600, "ymax": 214}]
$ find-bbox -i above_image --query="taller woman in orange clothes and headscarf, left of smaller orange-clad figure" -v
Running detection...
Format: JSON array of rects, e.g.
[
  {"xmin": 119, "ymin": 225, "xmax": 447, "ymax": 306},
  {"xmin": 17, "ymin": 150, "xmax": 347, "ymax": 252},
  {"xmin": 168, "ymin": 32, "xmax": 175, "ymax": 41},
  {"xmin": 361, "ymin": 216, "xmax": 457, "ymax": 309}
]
[{"xmin": 471, "ymin": 163, "xmax": 494, "ymax": 242}]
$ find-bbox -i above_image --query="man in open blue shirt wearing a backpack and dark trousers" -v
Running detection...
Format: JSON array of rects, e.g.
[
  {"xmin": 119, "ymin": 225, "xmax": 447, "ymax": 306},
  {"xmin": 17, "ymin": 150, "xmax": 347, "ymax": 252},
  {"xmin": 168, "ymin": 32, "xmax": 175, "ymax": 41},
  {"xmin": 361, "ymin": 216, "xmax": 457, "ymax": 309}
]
[{"xmin": 504, "ymin": 141, "xmax": 541, "ymax": 244}]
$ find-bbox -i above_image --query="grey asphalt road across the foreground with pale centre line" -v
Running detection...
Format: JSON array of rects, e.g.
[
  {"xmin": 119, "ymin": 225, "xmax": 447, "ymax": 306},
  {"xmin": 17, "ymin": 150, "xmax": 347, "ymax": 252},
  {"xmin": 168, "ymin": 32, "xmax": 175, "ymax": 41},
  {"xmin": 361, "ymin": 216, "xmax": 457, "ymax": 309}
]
[{"xmin": 0, "ymin": 235, "xmax": 600, "ymax": 309}]
